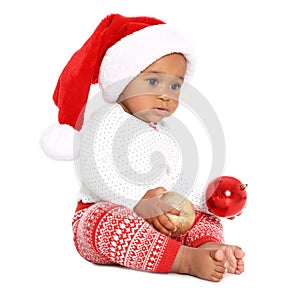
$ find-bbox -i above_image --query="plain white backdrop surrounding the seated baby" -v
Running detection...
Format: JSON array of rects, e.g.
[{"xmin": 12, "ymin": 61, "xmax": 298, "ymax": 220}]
[{"xmin": 0, "ymin": 0, "xmax": 300, "ymax": 291}]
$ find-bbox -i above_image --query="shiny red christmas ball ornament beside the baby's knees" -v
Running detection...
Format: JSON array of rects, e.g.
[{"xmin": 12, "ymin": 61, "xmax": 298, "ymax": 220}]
[{"xmin": 205, "ymin": 176, "xmax": 247, "ymax": 217}]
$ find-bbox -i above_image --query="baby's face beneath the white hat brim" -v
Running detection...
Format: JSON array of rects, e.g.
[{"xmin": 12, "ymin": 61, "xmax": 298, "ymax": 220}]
[{"xmin": 119, "ymin": 54, "xmax": 186, "ymax": 123}]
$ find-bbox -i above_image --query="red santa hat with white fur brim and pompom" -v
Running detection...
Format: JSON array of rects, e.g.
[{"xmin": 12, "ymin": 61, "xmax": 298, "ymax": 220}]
[{"xmin": 41, "ymin": 14, "xmax": 195, "ymax": 160}]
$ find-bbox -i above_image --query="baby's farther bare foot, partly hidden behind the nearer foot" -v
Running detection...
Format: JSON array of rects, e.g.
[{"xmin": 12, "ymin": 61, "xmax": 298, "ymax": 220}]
[{"xmin": 199, "ymin": 242, "xmax": 245, "ymax": 274}]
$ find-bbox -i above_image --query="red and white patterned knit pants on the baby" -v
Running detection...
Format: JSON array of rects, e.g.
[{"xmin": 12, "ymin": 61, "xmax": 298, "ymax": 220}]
[{"xmin": 72, "ymin": 202, "xmax": 223, "ymax": 273}]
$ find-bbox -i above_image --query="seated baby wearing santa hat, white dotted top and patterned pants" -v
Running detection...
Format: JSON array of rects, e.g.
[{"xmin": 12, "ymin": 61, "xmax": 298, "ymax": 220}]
[{"xmin": 41, "ymin": 14, "xmax": 245, "ymax": 282}]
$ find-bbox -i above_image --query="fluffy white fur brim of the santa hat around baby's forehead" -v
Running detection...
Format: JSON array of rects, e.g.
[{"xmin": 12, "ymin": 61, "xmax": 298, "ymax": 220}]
[{"xmin": 99, "ymin": 24, "xmax": 196, "ymax": 103}]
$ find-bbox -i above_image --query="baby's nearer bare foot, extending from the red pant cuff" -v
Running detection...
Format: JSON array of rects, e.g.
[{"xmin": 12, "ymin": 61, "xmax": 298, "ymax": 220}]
[{"xmin": 172, "ymin": 246, "xmax": 226, "ymax": 282}]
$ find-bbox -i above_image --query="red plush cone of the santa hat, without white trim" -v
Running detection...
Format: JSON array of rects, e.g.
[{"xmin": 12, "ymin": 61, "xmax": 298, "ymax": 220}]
[{"xmin": 53, "ymin": 14, "xmax": 164, "ymax": 130}]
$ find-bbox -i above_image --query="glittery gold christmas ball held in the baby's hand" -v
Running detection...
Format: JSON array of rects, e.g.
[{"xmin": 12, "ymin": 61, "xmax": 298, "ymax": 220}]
[{"xmin": 161, "ymin": 192, "xmax": 195, "ymax": 236}]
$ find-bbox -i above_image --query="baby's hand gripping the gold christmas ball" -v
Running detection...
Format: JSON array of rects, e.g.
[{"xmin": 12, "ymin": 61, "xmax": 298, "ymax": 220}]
[{"xmin": 133, "ymin": 187, "xmax": 180, "ymax": 235}]
